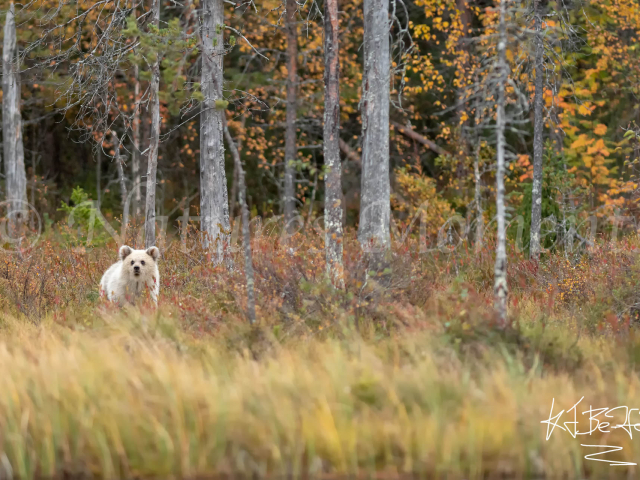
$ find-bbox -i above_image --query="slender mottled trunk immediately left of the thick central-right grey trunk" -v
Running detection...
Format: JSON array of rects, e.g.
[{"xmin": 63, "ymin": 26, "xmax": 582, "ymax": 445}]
[{"xmin": 323, "ymin": 0, "xmax": 344, "ymax": 289}]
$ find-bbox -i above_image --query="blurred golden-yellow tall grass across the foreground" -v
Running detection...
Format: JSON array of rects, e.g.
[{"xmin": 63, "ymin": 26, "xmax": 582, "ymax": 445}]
[{"xmin": 0, "ymin": 311, "xmax": 640, "ymax": 478}]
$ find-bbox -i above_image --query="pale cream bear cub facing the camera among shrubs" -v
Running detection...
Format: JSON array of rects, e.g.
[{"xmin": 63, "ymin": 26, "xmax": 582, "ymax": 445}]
[{"xmin": 100, "ymin": 245, "xmax": 160, "ymax": 305}]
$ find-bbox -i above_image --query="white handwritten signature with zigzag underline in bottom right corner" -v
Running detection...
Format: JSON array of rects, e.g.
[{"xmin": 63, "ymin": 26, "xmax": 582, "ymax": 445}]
[{"xmin": 540, "ymin": 397, "xmax": 640, "ymax": 466}]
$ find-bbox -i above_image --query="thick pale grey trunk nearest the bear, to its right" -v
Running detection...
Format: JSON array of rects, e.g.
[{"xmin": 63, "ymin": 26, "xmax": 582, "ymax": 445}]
[{"xmin": 200, "ymin": 0, "xmax": 230, "ymax": 264}]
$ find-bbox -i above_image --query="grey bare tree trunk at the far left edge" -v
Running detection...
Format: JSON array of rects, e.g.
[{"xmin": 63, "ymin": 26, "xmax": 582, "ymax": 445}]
[{"xmin": 2, "ymin": 2, "xmax": 28, "ymax": 238}]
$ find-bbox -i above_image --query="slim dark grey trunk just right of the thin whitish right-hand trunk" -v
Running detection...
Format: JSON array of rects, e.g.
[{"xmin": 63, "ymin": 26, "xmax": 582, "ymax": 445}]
[{"xmin": 529, "ymin": 0, "xmax": 544, "ymax": 263}]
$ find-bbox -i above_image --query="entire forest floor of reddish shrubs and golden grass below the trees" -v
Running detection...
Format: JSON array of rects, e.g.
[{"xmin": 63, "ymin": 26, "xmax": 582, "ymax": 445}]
[{"xmin": 0, "ymin": 226, "xmax": 640, "ymax": 479}]
